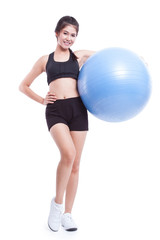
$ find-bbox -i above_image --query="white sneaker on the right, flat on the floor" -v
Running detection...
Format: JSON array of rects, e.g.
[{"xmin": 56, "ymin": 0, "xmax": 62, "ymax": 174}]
[{"xmin": 61, "ymin": 213, "xmax": 77, "ymax": 231}]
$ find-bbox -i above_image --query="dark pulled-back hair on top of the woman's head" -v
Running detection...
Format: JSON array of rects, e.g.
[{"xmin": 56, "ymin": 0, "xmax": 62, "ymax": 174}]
[{"xmin": 55, "ymin": 16, "xmax": 79, "ymax": 34}]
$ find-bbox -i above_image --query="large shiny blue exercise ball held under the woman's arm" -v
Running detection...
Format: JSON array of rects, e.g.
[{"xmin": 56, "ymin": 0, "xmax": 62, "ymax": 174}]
[{"xmin": 78, "ymin": 47, "xmax": 151, "ymax": 122}]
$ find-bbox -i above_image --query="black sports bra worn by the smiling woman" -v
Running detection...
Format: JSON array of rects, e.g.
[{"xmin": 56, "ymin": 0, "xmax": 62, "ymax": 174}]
[{"xmin": 46, "ymin": 49, "xmax": 79, "ymax": 85}]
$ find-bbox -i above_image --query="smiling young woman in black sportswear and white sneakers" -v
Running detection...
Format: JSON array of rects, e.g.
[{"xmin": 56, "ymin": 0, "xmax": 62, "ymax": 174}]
[{"xmin": 20, "ymin": 16, "xmax": 94, "ymax": 231}]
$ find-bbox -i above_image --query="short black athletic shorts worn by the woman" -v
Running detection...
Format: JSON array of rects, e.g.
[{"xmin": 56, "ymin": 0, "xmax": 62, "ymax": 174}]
[{"xmin": 46, "ymin": 97, "xmax": 88, "ymax": 131}]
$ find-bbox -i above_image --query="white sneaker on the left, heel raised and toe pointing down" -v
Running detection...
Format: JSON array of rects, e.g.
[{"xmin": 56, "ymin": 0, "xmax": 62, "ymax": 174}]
[{"xmin": 48, "ymin": 199, "xmax": 63, "ymax": 232}]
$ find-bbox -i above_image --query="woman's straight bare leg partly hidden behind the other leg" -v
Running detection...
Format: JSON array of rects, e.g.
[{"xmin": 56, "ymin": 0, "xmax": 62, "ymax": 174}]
[{"xmin": 65, "ymin": 131, "xmax": 87, "ymax": 213}]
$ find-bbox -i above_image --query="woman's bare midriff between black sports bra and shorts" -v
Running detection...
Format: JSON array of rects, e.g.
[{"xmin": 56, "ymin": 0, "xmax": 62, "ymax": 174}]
[{"xmin": 49, "ymin": 78, "xmax": 79, "ymax": 99}]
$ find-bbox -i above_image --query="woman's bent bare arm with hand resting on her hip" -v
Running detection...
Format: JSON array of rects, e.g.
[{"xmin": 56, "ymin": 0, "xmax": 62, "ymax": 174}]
[{"xmin": 19, "ymin": 56, "xmax": 56, "ymax": 105}]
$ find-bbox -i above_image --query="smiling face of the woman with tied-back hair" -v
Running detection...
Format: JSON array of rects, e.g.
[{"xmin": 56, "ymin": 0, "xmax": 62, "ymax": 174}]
[{"xmin": 56, "ymin": 25, "xmax": 77, "ymax": 49}]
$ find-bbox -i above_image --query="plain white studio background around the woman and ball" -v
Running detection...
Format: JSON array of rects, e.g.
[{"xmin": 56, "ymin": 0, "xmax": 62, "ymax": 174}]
[{"xmin": 0, "ymin": 0, "xmax": 160, "ymax": 240}]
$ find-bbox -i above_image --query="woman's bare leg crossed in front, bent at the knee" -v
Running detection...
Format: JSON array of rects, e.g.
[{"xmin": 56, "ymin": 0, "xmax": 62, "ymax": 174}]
[{"xmin": 50, "ymin": 123, "xmax": 76, "ymax": 204}]
